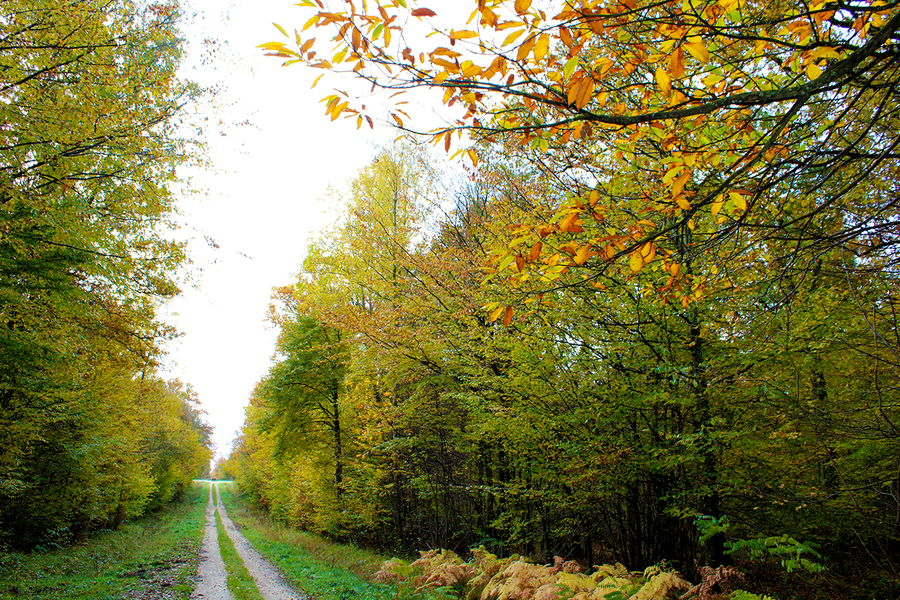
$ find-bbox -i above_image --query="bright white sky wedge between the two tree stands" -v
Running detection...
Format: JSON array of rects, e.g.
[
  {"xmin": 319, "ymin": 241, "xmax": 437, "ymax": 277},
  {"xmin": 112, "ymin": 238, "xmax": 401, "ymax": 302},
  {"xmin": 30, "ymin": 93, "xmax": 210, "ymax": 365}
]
[{"xmin": 162, "ymin": 0, "xmax": 386, "ymax": 455}]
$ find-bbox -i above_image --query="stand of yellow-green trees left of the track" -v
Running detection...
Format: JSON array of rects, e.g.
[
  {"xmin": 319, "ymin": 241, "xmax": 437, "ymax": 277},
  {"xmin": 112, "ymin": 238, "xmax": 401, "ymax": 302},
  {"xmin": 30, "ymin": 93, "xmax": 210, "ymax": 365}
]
[{"xmin": 0, "ymin": 0, "xmax": 212, "ymax": 551}]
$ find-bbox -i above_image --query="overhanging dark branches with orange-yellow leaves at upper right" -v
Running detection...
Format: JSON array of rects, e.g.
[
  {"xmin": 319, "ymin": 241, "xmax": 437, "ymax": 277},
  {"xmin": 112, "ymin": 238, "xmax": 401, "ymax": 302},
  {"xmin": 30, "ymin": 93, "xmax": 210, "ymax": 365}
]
[{"xmin": 263, "ymin": 0, "xmax": 900, "ymax": 310}]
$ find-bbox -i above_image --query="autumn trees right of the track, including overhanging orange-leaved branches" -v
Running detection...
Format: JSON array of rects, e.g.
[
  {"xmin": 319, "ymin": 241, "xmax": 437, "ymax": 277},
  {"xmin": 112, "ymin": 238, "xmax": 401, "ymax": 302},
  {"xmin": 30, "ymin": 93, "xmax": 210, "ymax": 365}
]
[{"xmin": 225, "ymin": 0, "xmax": 900, "ymax": 598}]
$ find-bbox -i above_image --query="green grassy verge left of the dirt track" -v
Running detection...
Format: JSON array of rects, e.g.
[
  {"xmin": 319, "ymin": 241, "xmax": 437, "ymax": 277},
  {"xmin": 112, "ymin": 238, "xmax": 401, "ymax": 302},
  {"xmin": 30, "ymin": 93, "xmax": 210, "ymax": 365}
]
[{"xmin": 0, "ymin": 483, "xmax": 208, "ymax": 600}]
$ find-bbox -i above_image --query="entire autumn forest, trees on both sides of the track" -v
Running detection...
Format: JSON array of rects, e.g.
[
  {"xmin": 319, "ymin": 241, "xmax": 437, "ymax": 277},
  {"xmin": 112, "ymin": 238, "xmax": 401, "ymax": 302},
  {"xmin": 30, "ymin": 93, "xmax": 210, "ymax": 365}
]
[{"xmin": 0, "ymin": 0, "xmax": 900, "ymax": 600}]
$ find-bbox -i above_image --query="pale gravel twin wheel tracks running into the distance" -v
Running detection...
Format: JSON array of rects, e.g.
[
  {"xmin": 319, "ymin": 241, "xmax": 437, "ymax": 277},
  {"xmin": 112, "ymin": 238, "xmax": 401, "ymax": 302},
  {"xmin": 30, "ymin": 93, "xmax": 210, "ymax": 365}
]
[{"xmin": 191, "ymin": 483, "xmax": 307, "ymax": 600}]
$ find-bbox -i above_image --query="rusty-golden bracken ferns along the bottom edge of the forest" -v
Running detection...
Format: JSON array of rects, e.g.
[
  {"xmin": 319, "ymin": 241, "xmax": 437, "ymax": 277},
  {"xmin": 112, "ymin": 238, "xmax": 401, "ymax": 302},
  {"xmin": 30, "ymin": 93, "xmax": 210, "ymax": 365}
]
[{"xmin": 375, "ymin": 547, "xmax": 772, "ymax": 600}]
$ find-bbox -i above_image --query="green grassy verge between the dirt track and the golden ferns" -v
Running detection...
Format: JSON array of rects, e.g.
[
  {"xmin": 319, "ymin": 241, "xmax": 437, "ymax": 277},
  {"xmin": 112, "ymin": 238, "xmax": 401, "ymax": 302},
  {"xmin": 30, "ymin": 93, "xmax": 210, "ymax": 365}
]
[{"xmin": 219, "ymin": 485, "xmax": 396, "ymax": 600}]
